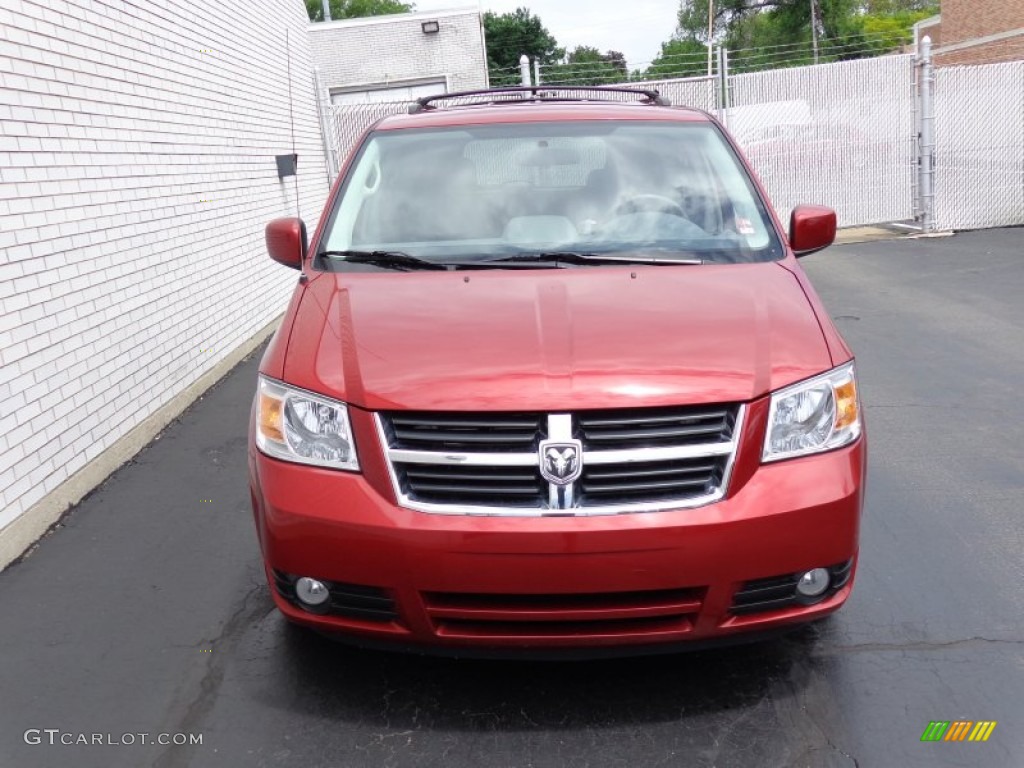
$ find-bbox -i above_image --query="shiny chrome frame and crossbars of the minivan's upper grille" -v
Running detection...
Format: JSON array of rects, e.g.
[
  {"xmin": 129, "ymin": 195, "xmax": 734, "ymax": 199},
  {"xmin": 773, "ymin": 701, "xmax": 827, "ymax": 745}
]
[{"xmin": 374, "ymin": 404, "xmax": 746, "ymax": 517}]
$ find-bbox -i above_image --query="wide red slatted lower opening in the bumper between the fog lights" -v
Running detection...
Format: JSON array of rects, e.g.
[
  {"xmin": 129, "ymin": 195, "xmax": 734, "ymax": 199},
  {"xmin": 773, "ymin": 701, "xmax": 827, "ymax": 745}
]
[{"xmin": 422, "ymin": 589, "xmax": 705, "ymax": 639}]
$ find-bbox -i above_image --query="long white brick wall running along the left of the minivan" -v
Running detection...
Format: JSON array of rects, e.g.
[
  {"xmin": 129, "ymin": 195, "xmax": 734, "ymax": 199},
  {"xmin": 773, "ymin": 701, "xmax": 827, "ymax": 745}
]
[{"xmin": 0, "ymin": 0, "xmax": 327, "ymax": 529}]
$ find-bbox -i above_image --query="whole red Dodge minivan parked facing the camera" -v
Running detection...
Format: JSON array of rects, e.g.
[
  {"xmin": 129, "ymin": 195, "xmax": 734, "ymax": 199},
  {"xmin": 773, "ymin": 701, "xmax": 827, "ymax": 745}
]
[{"xmin": 249, "ymin": 88, "xmax": 865, "ymax": 655}]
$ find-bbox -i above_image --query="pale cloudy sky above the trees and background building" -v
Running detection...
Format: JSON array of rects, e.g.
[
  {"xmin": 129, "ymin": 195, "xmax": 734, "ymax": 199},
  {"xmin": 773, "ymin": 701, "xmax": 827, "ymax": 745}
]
[{"xmin": 415, "ymin": 0, "xmax": 679, "ymax": 69}]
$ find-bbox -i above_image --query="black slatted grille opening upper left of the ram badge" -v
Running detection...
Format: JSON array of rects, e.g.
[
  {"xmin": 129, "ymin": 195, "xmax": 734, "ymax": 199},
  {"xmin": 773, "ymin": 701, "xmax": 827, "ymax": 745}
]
[{"xmin": 388, "ymin": 413, "xmax": 547, "ymax": 453}]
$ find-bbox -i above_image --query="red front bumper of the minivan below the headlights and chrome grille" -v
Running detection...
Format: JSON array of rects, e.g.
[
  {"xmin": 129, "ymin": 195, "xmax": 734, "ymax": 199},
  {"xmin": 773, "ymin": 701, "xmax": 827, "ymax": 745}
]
[{"xmin": 250, "ymin": 405, "xmax": 865, "ymax": 652}]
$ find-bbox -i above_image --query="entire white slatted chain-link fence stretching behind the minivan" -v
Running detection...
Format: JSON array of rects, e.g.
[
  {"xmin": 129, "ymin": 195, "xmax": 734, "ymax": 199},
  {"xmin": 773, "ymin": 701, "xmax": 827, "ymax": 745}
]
[{"xmin": 322, "ymin": 54, "xmax": 1024, "ymax": 229}]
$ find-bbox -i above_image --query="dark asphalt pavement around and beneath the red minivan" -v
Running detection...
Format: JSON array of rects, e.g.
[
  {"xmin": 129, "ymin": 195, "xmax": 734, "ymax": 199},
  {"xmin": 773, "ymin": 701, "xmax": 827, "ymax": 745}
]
[{"xmin": 0, "ymin": 229, "xmax": 1024, "ymax": 768}]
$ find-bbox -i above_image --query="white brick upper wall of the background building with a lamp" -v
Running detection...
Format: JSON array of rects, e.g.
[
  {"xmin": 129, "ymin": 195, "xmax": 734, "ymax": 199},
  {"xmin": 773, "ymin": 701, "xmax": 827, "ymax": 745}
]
[{"xmin": 309, "ymin": 8, "xmax": 487, "ymax": 96}]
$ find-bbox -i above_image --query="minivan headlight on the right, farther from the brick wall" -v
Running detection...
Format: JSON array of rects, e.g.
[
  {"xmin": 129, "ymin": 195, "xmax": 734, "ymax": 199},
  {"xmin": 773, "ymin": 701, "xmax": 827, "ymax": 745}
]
[{"xmin": 761, "ymin": 362, "xmax": 860, "ymax": 462}]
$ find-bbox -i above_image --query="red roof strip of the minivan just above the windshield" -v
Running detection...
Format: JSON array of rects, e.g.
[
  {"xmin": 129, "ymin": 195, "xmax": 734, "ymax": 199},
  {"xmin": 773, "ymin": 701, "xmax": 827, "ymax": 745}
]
[{"xmin": 377, "ymin": 101, "xmax": 711, "ymax": 131}]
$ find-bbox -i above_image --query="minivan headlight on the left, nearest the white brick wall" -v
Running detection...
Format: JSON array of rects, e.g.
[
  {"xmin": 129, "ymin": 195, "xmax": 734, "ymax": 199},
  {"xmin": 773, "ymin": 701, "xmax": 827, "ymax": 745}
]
[{"xmin": 256, "ymin": 376, "xmax": 359, "ymax": 471}]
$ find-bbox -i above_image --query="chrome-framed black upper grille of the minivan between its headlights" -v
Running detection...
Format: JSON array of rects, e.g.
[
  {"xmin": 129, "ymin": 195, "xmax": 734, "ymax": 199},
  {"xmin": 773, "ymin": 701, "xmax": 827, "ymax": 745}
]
[{"xmin": 377, "ymin": 404, "xmax": 743, "ymax": 515}]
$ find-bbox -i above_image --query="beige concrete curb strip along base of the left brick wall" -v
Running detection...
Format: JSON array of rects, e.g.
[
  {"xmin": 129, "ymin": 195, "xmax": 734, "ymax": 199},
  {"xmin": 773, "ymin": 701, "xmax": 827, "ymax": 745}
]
[{"xmin": 0, "ymin": 316, "xmax": 281, "ymax": 571}]
